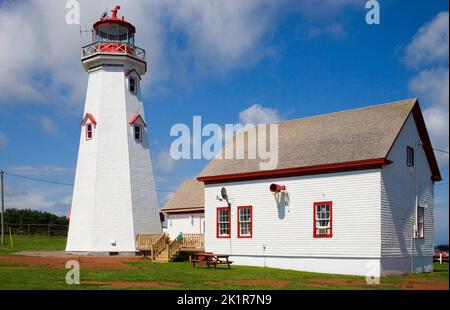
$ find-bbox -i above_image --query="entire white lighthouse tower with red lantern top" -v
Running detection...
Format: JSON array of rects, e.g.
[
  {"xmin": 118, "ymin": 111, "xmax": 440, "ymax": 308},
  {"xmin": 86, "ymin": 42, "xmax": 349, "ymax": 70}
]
[{"xmin": 66, "ymin": 6, "xmax": 161, "ymax": 253}]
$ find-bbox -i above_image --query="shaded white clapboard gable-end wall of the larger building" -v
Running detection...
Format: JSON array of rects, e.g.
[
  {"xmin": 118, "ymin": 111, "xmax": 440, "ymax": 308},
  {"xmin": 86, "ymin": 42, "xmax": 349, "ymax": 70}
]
[{"xmin": 381, "ymin": 116, "xmax": 434, "ymax": 257}]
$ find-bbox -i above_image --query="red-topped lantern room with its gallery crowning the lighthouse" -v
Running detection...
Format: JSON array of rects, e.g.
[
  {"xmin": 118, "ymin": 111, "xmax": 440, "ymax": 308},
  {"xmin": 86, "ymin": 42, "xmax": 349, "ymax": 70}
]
[{"xmin": 81, "ymin": 6, "xmax": 147, "ymax": 75}]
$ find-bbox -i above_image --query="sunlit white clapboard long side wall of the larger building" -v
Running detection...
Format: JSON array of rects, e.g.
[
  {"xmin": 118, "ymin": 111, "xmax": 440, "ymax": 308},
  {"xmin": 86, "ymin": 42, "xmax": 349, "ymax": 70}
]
[{"xmin": 205, "ymin": 170, "xmax": 381, "ymax": 258}]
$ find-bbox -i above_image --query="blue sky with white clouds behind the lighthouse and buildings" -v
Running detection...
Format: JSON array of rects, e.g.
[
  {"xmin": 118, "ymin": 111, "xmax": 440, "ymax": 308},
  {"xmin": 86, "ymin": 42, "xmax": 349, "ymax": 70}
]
[{"xmin": 0, "ymin": 0, "xmax": 449, "ymax": 242}]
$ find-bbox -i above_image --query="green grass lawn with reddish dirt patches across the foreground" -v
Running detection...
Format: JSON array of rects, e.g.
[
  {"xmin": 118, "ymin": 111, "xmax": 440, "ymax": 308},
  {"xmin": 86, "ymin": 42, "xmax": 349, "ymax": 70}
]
[{"xmin": 0, "ymin": 237, "xmax": 448, "ymax": 290}]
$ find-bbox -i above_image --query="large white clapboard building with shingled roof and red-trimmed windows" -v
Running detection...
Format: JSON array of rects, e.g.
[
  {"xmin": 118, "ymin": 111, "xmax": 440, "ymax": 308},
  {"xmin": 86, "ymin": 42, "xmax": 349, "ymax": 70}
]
[{"xmin": 198, "ymin": 99, "xmax": 441, "ymax": 276}]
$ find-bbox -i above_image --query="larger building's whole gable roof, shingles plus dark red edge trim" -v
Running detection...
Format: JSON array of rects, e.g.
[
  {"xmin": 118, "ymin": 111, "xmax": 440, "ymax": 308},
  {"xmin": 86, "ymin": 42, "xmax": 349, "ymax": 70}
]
[{"xmin": 198, "ymin": 99, "xmax": 440, "ymax": 182}]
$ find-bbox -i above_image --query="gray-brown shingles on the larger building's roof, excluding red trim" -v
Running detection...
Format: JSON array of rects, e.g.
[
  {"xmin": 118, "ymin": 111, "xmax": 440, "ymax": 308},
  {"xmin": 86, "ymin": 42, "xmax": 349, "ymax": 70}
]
[{"xmin": 200, "ymin": 99, "xmax": 417, "ymax": 177}]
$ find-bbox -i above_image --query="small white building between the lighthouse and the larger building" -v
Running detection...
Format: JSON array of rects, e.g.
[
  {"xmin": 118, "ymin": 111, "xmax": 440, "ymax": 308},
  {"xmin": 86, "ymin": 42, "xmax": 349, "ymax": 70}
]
[{"xmin": 161, "ymin": 180, "xmax": 205, "ymax": 240}]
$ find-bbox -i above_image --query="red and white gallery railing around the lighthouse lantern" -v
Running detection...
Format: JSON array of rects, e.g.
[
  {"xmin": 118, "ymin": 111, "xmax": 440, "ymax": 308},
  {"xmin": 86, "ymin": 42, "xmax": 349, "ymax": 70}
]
[{"xmin": 81, "ymin": 42, "xmax": 145, "ymax": 61}]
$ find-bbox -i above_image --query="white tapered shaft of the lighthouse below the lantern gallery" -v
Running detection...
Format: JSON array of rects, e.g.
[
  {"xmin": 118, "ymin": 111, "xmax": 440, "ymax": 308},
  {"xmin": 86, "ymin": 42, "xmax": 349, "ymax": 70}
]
[{"xmin": 66, "ymin": 66, "xmax": 162, "ymax": 252}]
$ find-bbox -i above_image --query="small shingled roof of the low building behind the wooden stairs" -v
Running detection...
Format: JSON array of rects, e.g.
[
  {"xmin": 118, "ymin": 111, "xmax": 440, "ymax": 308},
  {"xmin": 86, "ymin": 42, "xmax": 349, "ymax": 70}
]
[{"xmin": 161, "ymin": 180, "xmax": 205, "ymax": 212}]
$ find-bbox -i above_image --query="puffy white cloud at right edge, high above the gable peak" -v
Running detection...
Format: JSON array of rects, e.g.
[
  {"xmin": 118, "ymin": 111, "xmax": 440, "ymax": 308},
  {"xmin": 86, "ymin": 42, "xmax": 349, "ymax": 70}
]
[{"xmin": 405, "ymin": 12, "xmax": 449, "ymax": 68}]
